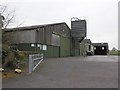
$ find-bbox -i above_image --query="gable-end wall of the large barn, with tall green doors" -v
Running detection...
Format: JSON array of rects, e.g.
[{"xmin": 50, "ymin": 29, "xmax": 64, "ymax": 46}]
[{"xmin": 44, "ymin": 23, "xmax": 70, "ymax": 57}]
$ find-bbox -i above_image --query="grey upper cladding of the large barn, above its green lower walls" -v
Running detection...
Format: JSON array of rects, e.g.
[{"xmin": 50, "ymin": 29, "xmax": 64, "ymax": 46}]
[{"xmin": 8, "ymin": 23, "xmax": 70, "ymax": 46}]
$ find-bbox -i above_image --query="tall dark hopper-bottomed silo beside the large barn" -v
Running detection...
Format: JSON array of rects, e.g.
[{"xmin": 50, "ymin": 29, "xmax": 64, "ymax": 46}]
[{"xmin": 71, "ymin": 18, "xmax": 87, "ymax": 56}]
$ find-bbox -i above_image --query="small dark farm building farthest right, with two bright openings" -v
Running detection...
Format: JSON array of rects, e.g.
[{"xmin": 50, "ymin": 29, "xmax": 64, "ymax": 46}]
[{"xmin": 93, "ymin": 43, "xmax": 109, "ymax": 55}]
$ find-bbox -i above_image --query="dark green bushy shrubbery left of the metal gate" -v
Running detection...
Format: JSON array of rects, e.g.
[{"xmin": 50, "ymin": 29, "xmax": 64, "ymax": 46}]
[{"xmin": 2, "ymin": 45, "xmax": 28, "ymax": 69}]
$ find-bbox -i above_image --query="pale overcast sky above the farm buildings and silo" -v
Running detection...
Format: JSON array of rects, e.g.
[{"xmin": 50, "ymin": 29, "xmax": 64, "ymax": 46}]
[{"xmin": 0, "ymin": 0, "xmax": 119, "ymax": 49}]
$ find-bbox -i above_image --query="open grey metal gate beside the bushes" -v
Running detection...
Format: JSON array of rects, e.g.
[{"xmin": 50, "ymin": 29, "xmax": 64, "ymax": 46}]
[{"xmin": 29, "ymin": 54, "xmax": 43, "ymax": 73}]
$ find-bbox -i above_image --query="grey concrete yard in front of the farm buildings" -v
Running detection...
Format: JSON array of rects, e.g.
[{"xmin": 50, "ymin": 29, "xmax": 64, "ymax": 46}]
[{"xmin": 3, "ymin": 56, "xmax": 118, "ymax": 88}]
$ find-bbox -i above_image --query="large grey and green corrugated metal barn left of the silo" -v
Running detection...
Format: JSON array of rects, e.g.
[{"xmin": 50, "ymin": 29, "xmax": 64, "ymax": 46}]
[{"xmin": 6, "ymin": 23, "xmax": 71, "ymax": 57}]
